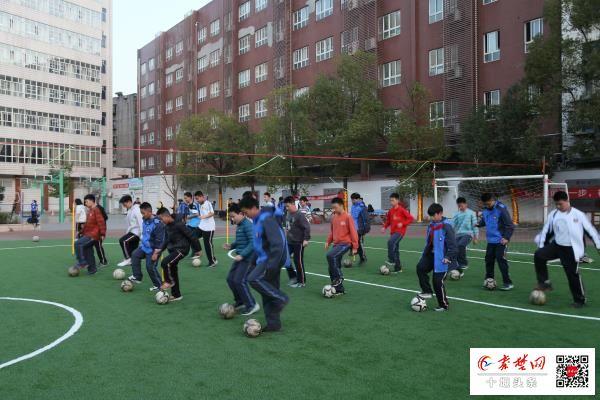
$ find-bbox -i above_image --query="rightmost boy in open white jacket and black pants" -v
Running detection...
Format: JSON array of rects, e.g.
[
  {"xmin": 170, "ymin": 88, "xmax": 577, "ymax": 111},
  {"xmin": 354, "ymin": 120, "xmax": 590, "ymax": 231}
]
[{"xmin": 533, "ymin": 191, "xmax": 600, "ymax": 308}]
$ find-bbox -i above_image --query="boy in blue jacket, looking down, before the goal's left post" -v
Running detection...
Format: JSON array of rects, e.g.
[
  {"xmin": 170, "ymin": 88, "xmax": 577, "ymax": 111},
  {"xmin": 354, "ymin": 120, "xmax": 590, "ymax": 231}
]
[{"xmin": 417, "ymin": 203, "xmax": 457, "ymax": 311}]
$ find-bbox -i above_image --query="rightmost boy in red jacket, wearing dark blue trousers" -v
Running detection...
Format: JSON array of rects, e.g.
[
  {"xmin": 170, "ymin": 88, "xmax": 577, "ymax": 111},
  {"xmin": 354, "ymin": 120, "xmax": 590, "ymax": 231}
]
[{"xmin": 381, "ymin": 193, "xmax": 415, "ymax": 273}]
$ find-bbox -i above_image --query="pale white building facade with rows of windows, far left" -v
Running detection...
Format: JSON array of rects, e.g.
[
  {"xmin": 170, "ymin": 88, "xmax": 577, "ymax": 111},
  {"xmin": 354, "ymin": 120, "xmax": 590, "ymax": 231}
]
[{"xmin": 0, "ymin": 0, "xmax": 112, "ymax": 212}]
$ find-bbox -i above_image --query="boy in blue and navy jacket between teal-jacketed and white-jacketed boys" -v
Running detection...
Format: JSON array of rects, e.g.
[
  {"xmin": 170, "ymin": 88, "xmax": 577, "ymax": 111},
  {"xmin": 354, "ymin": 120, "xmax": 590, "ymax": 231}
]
[{"xmin": 477, "ymin": 193, "xmax": 514, "ymax": 290}]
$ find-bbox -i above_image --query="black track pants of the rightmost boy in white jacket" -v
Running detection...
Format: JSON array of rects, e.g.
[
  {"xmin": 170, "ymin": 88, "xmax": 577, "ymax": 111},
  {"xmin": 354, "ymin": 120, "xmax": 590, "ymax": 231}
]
[{"xmin": 533, "ymin": 242, "xmax": 585, "ymax": 304}]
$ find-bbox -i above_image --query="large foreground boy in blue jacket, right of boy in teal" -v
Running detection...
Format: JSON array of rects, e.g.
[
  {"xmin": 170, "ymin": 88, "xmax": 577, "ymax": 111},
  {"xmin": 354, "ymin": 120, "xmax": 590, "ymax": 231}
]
[{"xmin": 240, "ymin": 197, "xmax": 290, "ymax": 332}]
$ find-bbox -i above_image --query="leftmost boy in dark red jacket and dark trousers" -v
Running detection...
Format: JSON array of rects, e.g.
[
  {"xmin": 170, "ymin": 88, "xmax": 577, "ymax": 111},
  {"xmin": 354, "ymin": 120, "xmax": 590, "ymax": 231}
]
[{"xmin": 75, "ymin": 194, "xmax": 106, "ymax": 275}]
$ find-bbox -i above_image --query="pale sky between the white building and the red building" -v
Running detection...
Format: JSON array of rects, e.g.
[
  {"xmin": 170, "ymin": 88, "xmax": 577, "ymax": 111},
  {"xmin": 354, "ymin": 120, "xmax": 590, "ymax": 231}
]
[{"xmin": 113, "ymin": 0, "xmax": 210, "ymax": 94}]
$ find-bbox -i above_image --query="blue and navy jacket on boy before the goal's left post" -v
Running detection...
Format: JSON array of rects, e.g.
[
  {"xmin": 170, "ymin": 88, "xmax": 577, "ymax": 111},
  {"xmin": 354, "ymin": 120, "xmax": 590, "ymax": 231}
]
[{"xmin": 423, "ymin": 218, "xmax": 458, "ymax": 272}]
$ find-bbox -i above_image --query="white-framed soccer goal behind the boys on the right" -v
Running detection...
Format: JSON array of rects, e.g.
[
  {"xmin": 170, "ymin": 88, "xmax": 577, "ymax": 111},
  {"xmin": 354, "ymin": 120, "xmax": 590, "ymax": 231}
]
[{"xmin": 434, "ymin": 175, "xmax": 568, "ymax": 256}]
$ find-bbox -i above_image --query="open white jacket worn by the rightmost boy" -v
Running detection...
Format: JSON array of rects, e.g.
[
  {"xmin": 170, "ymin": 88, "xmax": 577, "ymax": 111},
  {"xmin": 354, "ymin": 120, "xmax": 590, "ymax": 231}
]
[{"xmin": 536, "ymin": 207, "xmax": 600, "ymax": 260}]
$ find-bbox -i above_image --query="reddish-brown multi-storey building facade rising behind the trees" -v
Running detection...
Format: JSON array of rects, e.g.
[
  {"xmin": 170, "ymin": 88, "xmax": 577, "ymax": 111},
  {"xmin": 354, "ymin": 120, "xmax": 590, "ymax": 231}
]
[{"xmin": 137, "ymin": 0, "xmax": 553, "ymax": 175}]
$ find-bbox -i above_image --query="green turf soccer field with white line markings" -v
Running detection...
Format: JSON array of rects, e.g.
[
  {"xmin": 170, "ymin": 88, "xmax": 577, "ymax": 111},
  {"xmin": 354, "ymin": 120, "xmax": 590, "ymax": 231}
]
[{"xmin": 0, "ymin": 235, "xmax": 600, "ymax": 400}]
